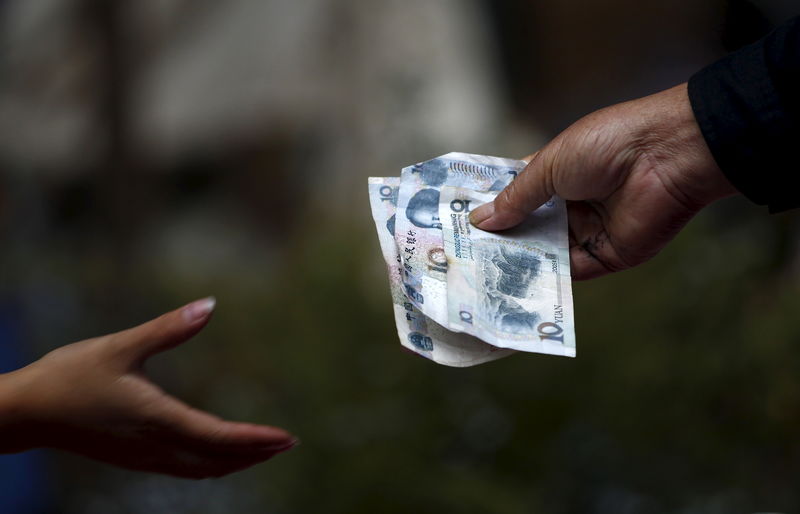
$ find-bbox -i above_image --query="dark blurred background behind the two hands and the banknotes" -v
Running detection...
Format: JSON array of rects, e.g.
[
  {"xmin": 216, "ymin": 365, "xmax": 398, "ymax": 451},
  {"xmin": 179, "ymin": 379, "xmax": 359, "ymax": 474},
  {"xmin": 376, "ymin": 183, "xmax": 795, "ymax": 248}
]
[{"xmin": 0, "ymin": 0, "xmax": 800, "ymax": 514}]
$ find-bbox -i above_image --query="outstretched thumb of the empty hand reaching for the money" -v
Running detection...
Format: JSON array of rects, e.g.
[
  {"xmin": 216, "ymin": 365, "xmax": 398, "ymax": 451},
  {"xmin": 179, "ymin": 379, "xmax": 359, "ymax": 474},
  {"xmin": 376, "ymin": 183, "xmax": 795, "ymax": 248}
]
[{"xmin": 113, "ymin": 296, "xmax": 216, "ymax": 363}]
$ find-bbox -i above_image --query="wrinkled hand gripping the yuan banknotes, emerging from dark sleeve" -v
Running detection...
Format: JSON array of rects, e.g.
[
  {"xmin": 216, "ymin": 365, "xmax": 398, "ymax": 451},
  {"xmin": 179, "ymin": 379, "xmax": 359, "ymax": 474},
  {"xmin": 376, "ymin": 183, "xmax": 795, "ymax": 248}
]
[{"xmin": 470, "ymin": 84, "xmax": 736, "ymax": 280}]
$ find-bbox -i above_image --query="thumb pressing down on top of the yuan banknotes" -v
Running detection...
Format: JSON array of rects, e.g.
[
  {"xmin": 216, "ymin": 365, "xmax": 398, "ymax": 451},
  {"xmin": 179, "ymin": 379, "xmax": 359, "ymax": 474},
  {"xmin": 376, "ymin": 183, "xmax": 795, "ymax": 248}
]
[{"xmin": 469, "ymin": 147, "xmax": 554, "ymax": 231}]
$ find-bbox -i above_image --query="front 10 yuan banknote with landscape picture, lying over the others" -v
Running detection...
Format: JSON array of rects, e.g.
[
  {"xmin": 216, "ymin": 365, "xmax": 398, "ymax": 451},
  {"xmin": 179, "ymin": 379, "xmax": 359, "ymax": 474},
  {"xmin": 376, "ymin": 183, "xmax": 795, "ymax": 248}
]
[{"xmin": 439, "ymin": 186, "xmax": 575, "ymax": 357}]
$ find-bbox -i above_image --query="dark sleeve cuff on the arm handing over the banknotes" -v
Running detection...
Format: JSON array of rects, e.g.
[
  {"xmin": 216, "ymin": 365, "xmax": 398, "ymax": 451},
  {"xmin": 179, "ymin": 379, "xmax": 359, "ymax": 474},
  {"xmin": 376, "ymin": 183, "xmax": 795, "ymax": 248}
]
[{"xmin": 689, "ymin": 17, "xmax": 800, "ymax": 212}]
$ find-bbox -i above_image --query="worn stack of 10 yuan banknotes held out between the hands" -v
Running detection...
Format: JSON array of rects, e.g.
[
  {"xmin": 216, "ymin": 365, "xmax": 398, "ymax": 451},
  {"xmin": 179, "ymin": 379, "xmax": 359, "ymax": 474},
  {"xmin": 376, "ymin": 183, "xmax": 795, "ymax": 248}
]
[{"xmin": 369, "ymin": 153, "xmax": 575, "ymax": 366}]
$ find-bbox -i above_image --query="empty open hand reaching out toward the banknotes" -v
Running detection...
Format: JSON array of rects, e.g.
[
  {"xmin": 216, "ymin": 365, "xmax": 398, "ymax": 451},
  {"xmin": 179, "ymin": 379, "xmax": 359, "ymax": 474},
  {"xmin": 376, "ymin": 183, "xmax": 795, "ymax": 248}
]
[{"xmin": 0, "ymin": 299, "xmax": 297, "ymax": 478}]
